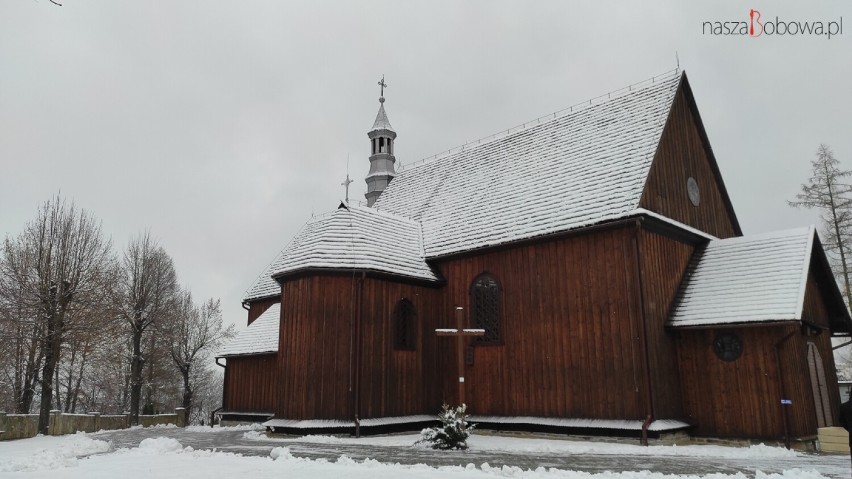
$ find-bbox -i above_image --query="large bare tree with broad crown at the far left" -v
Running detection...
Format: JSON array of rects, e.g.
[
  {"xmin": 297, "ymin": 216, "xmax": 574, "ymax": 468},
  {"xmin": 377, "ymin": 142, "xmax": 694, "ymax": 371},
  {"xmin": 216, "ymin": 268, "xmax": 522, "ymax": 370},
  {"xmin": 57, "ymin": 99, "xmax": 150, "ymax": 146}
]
[{"xmin": 0, "ymin": 196, "xmax": 112, "ymax": 434}]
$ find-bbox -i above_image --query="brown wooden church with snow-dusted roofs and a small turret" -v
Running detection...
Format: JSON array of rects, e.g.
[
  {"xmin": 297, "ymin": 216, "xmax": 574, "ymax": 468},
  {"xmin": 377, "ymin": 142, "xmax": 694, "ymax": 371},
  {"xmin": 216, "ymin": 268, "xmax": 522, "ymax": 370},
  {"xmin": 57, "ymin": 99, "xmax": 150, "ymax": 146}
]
[{"xmin": 219, "ymin": 72, "xmax": 852, "ymax": 440}]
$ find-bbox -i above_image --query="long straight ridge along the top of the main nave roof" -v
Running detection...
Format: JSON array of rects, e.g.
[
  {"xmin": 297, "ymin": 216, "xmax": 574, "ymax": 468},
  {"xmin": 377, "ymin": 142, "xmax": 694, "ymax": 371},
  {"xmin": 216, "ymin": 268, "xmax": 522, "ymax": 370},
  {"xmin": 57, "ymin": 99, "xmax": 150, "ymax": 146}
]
[{"xmin": 397, "ymin": 68, "xmax": 685, "ymax": 173}]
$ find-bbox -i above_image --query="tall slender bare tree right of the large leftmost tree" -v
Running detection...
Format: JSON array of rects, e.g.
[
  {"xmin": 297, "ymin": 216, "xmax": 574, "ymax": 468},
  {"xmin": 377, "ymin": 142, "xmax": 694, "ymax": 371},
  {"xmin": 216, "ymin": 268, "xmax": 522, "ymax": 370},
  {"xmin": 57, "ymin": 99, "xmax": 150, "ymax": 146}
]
[{"xmin": 117, "ymin": 233, "xmax": 177, "ymax": 424}]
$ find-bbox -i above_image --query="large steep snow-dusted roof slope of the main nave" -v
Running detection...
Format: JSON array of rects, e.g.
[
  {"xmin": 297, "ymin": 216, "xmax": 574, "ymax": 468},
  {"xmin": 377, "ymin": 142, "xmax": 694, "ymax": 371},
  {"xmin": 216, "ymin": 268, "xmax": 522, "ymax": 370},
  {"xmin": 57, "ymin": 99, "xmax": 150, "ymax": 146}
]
[{"xmin": 375, "ymin": 71, "xmax": 680, "ymax": 258}]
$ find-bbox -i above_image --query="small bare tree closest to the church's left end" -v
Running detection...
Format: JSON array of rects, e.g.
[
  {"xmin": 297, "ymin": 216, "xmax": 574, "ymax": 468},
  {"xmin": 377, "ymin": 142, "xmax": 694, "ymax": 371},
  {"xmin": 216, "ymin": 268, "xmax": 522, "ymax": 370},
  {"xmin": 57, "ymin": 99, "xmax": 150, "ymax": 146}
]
[{"xmin": 170, "ymin": 291, "xmax": 234, "ymax": 420}]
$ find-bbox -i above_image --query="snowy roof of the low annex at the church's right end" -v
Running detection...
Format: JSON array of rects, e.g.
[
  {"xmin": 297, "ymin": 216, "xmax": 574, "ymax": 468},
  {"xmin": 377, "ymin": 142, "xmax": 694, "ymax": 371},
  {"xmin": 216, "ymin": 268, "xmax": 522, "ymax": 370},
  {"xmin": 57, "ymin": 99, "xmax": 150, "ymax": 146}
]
[{"xmin": 669, "ymin": 226, "xmax": 814, "ymax": 327}]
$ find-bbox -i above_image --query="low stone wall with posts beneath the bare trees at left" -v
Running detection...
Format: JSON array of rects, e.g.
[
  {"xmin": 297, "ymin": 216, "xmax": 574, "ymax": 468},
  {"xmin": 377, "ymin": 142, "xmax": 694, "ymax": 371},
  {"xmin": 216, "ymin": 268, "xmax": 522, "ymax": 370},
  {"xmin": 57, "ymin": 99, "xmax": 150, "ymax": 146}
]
[{"xmin": 0, "ymin": 408, "xmax": 186, "ymax": 441}]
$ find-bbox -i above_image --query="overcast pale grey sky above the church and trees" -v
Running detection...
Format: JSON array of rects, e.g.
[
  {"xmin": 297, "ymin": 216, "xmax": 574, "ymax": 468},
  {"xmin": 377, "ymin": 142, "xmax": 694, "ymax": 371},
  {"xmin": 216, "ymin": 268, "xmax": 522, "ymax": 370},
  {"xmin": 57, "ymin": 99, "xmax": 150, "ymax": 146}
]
[{"xmin": 0, "ymin": 0, "xmax": 852, "ymax": 326}]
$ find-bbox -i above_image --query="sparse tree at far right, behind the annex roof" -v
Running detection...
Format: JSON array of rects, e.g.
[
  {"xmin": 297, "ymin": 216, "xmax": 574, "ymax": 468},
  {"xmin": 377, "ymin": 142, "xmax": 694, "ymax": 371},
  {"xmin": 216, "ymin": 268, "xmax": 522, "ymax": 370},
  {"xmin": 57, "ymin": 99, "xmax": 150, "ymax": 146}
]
[{"xmin": 788, "ymin": 144, "xmax": 852, "ymax": 308}]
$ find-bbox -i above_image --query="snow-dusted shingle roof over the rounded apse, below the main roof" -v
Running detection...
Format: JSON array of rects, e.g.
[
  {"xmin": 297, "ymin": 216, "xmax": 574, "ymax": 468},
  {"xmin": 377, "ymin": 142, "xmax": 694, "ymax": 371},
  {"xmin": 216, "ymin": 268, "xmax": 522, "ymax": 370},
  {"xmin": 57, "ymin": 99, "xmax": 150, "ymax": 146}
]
[{"xmin": 270, "ymin": 206, "xmax": 439, "ymax": 281}]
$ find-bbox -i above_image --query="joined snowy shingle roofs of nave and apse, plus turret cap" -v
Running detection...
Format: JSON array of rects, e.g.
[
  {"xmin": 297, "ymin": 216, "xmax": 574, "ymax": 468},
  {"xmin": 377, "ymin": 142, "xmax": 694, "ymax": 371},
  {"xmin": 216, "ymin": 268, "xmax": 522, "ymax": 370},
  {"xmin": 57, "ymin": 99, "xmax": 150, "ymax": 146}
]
[{"xmin": 244, "ymin": 74, "xmax": 681, "ymax": 301}]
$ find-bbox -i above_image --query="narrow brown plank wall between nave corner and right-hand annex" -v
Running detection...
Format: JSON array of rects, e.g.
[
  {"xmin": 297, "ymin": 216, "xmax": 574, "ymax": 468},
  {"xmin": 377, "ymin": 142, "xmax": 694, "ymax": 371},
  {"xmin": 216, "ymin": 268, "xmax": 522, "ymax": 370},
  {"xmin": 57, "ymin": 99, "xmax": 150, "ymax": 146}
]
[{"xmin": 639, "ymin": 230, "xmax": 694, "ymax": 418}]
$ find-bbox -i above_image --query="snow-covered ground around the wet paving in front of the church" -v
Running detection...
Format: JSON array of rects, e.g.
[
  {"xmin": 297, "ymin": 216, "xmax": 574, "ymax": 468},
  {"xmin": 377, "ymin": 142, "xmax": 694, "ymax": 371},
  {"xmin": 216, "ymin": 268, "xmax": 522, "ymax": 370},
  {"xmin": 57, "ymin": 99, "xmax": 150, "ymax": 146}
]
[{"xmin": 0, "ymin": 427, "xmax": 849, "ymax": 479}]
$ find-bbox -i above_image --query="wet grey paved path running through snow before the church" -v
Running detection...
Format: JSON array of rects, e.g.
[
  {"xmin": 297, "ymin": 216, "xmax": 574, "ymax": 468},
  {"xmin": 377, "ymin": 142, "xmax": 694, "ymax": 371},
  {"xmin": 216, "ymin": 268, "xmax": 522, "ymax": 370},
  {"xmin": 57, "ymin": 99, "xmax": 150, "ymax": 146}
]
[{"xmin": 90, "ymin": 428, "xmax": 850, "ymax": 479}]
